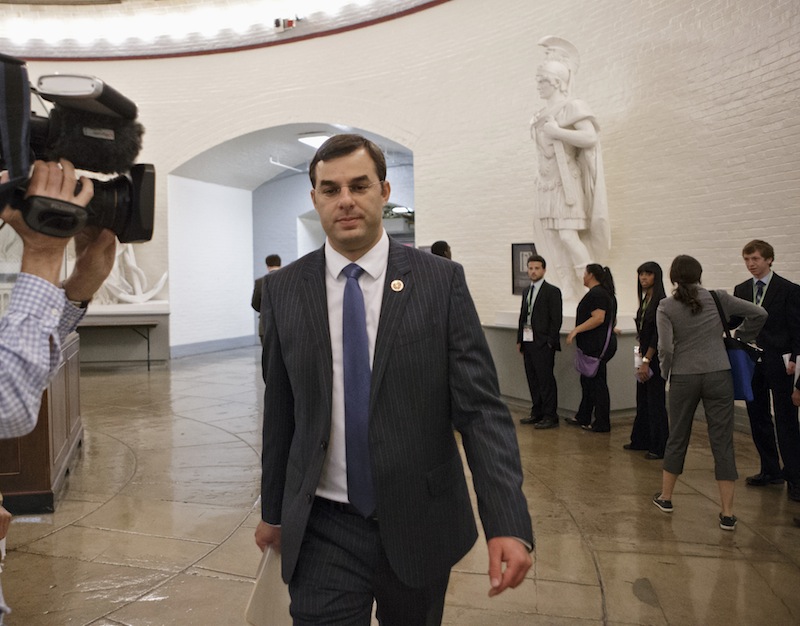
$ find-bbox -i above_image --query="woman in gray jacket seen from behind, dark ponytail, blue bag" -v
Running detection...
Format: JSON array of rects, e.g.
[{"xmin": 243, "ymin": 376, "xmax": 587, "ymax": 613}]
[{"xmin": 653, "ymin": 254, "xmax": 767, "ymax": 530}]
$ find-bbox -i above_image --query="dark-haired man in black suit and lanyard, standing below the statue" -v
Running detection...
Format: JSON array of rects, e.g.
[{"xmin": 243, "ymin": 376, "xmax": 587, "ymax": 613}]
[{"xmin": 517, "ymin": 254, "xmax": 563, "ymax": 429}]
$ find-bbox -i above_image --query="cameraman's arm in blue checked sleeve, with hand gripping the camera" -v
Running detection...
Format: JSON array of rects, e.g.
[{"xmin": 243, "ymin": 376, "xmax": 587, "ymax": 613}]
[{"xmin": 0, "ymin": 161, "xmax": 100, "ymax": 438}]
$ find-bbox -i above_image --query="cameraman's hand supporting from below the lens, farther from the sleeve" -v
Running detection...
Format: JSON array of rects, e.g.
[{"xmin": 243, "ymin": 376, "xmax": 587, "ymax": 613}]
[{"xmin": 64, "ymin": 226, "xmax": 117, "ymax": 301}]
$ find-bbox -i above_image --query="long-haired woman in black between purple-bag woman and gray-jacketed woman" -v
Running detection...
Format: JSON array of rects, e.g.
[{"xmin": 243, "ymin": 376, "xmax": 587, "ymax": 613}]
[{"xmin": 623, "ymin": 261, "xmax": 669, "ymax": 459}]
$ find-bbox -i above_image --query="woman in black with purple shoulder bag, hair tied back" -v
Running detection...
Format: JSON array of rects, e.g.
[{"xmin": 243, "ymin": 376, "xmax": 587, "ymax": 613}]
[{"xmin": 566, "ymin": 263, "xmax": 617, "ymax": 433}]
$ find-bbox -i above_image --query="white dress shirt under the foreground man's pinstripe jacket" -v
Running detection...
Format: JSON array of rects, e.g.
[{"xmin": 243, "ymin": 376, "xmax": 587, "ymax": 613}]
[{"xmin": 316, "ymin": 231, "xmax": 389, "ymax": 502}]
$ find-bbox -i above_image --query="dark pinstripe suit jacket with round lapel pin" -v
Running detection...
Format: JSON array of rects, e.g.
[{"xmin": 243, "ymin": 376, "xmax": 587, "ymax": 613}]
[{"xmin": 261, "ymin": 242, "xmax": 533, "ymax": 586}]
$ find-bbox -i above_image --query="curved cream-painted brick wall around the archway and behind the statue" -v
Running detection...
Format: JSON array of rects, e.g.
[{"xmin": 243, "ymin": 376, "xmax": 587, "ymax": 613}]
[{"xmin": 25, "ymin": 0, "xmax": 800, "ymax": 341}]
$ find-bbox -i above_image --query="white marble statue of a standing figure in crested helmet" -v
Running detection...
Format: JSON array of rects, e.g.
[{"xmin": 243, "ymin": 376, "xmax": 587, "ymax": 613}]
[{"xmin": 531, "ymin": 37, "xmax": 611, "ymax": 300}]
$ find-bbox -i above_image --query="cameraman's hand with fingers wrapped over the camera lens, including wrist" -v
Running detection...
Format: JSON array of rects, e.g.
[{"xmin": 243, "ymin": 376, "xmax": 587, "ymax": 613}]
[{"xmin": 0, "ymin": 159, "xmax": 94, "ymax": 285}]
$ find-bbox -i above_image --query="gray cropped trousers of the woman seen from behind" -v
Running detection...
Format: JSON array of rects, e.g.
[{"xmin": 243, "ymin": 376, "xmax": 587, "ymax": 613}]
[{"xmin": 664, "ymin": 370, "xmax": 739, "ymax": 480}]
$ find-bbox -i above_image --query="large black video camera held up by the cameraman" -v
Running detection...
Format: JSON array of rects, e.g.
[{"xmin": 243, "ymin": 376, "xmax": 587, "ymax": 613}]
[{"xmin": 0, "ymin": 54, "xmax": 155, "ymax": 243}]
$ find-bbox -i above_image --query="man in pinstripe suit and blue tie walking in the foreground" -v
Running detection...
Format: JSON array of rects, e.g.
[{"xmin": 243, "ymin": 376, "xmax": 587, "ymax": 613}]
[{"xmin": 256, "ymin": 135, "xmax": 533, "ymax": 626}]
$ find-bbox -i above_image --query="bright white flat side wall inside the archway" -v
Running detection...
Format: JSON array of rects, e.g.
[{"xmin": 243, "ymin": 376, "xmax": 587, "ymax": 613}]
[{"xmin": 168, "ymin": 176, "xmax": 254, "ymax": 348}]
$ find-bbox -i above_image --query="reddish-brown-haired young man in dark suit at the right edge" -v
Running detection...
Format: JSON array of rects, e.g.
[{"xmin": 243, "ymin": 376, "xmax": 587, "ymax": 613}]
[{"xmin": 731, "ymin": 239, "xmax": 800, "ymax": 501}]
